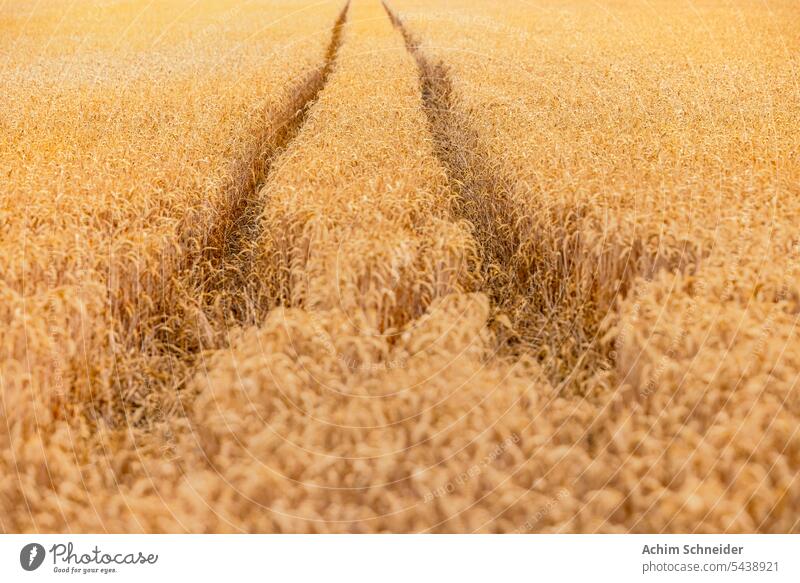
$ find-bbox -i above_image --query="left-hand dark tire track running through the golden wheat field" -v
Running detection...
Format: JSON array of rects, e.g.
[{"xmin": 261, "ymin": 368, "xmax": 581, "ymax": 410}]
[{"xmin": 114, "ymin": 2, "xmax": 350, "ymax": 424}]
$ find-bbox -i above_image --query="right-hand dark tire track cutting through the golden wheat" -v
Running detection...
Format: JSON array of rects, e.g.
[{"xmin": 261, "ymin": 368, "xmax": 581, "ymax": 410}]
[{"xmin": 383, "ymin": 2, "xmax": 605, "ymax": 385}]
